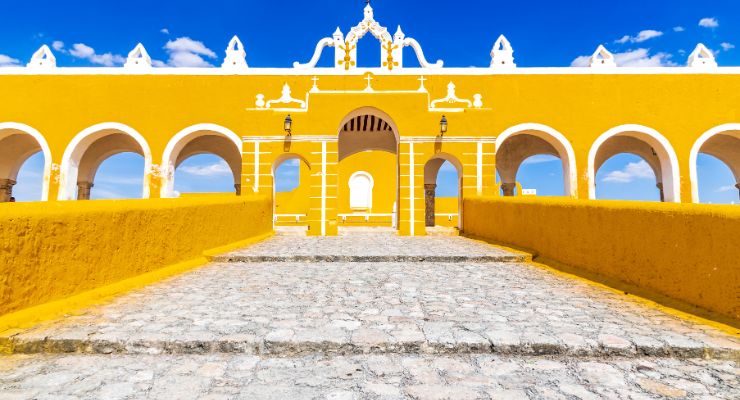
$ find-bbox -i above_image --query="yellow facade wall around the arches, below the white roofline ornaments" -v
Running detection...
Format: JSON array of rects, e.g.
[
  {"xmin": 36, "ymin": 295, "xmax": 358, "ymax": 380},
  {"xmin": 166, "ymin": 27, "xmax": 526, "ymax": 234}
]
[{"xmin": 0, "ymin": 70, "xmax": 740, "ymax": 235}]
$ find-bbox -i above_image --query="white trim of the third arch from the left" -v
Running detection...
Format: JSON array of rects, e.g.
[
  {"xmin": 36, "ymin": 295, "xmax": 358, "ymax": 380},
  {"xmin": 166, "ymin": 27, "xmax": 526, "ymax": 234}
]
[{"xmin": 160, "ymin": 123, "xmax": 242, "ymax": 198}]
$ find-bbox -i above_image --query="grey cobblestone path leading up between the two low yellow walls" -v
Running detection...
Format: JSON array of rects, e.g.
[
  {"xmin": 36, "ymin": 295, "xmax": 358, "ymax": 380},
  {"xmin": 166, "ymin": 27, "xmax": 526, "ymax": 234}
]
[{"xmin": 0, "ymin": 234, "xmax": 740, "ymax": 399}]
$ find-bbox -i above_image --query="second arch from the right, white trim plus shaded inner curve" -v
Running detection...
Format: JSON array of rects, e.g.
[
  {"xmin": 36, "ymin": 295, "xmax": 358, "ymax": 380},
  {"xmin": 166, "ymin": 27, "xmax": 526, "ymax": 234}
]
[{"xmin": 588, "ymin": 124, "xmax": 681, "ymax": 203}]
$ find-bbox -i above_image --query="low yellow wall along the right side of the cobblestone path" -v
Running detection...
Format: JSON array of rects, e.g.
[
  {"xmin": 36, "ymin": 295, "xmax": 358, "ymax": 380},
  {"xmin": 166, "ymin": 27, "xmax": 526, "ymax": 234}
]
[{"xmin": 464, "ymin": 197, "xmax": 740, "ymax": 326}]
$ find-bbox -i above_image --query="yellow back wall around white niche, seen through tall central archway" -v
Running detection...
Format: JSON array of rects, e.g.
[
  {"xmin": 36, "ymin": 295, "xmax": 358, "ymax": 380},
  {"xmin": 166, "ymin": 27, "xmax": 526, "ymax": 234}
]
[{"xmin": 339, "ymin": 151, "xmax": 398, "ymax": 226}]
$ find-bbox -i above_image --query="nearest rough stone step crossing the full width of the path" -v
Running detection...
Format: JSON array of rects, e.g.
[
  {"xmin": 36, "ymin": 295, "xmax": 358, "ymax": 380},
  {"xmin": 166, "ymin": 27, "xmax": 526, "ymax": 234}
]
[{"xmin": 0, "ymin": 330, "xmax": 740, "ymax": 361}]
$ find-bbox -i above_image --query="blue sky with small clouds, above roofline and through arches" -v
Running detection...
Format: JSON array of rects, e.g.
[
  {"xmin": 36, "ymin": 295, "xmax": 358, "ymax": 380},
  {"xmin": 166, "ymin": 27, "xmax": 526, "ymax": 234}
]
[{"xmin": 0, "ymin": 0, "xmax": 740, "ymax": 203}]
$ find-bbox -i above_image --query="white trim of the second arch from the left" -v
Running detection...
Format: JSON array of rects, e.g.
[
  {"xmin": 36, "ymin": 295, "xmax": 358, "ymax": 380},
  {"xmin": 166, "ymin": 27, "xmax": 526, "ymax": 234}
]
[{"xmin": 58, "ymin": 122, "xmax": 152, "ymax": 200}]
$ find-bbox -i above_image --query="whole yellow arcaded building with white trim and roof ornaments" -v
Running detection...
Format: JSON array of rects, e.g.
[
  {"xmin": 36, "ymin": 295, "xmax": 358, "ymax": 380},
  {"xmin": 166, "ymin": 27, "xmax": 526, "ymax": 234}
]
[{"xmin": 0, "ymin": 5, "xmax": 740, "ymax": 235}]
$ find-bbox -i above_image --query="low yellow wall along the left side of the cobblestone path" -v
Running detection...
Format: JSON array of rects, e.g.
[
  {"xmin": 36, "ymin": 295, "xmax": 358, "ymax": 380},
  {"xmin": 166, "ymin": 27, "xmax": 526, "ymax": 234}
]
[{"xmin": 0, "ymin": 196, "xmax": 272, "ymax": 316}]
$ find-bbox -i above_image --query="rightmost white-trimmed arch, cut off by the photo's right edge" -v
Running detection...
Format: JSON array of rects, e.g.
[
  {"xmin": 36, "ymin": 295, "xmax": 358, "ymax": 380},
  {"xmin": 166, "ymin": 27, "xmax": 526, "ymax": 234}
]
[{"xmin": 689, "ymin": 124, "xmax": 740, "ymax": 203}]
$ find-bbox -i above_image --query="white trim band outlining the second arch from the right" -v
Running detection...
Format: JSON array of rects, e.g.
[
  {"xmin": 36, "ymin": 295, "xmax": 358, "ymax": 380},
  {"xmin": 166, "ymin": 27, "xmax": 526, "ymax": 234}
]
[{"xmin": 588, "ymin": 124, "xmax": 681, "ymax": 203}]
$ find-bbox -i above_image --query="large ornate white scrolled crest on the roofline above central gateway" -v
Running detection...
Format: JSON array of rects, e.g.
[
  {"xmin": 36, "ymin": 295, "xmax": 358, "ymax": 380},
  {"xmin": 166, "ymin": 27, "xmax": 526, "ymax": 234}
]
[{"xmin": 293, "ymin": 3, "xmax": 444, "ymax": 71}]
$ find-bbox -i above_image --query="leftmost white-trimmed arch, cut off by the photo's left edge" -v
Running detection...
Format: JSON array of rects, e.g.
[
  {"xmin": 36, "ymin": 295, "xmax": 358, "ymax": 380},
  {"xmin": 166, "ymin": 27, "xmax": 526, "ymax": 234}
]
[{"xmin": 0, "ymin": 122, "xmax": 51, "ymax": 203}]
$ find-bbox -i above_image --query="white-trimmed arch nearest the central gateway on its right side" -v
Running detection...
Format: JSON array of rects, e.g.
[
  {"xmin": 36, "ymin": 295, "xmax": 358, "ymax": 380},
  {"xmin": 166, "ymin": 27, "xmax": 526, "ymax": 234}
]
[{"xmin": 496, "ymin": 124, "xmax": 577, "ymax": 197}]
